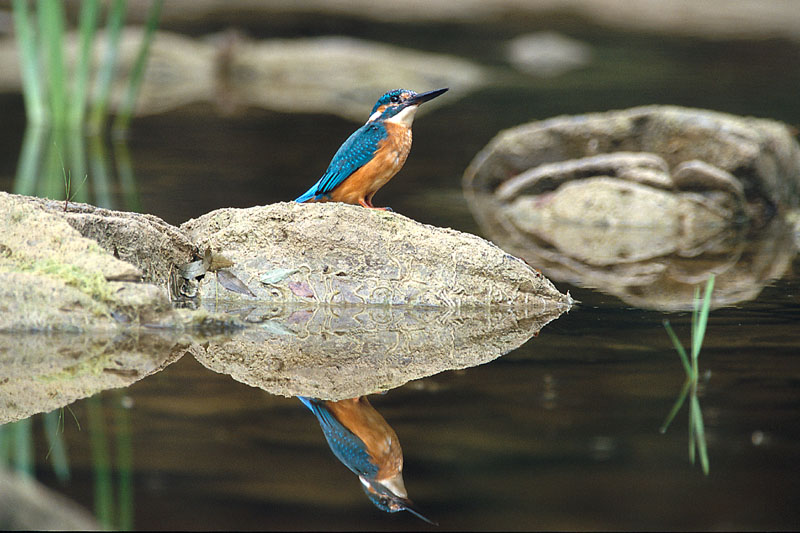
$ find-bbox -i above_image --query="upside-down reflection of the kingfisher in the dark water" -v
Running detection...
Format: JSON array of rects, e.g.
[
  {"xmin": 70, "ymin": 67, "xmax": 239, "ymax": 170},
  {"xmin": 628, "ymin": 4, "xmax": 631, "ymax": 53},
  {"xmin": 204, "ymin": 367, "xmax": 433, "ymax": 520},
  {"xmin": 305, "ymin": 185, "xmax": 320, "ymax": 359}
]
[{"xmin": 298, "ymin": 396, "xmax": 437, "ymax": 525}]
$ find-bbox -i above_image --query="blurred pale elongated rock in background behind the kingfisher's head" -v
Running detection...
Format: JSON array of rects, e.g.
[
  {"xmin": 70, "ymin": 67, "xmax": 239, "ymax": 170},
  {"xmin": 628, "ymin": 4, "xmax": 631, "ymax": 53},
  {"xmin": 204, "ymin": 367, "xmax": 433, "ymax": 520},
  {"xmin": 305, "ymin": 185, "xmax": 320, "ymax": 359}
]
[{"xmin": 228, "ymin": 36, "xmax": 488, "ymax": 119}]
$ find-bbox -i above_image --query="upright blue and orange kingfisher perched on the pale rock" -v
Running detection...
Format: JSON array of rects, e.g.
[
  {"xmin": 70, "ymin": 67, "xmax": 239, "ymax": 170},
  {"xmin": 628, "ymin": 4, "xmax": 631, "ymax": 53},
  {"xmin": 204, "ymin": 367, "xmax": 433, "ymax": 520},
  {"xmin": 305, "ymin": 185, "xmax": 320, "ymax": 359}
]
[{"xmin": 295, "ymin": 87, "xmax": 448, "ymax": 209}]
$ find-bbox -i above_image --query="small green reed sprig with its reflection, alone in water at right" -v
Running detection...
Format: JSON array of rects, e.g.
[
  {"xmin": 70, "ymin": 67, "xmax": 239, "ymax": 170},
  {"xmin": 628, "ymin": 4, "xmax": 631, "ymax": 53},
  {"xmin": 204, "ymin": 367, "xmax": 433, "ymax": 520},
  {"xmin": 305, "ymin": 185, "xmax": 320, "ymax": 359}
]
[{"xmin": 660, "ymin": 274, "xmax": 714, "ymax": 475}]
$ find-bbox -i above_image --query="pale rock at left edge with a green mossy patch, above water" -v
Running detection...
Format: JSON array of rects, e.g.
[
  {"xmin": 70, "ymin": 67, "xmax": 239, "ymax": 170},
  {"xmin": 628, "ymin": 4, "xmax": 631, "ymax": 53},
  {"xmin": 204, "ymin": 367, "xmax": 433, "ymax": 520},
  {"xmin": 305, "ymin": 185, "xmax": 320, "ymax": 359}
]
[{"xmin": 0, "ymin": 192, "xmax": 178, "ymax": 332}]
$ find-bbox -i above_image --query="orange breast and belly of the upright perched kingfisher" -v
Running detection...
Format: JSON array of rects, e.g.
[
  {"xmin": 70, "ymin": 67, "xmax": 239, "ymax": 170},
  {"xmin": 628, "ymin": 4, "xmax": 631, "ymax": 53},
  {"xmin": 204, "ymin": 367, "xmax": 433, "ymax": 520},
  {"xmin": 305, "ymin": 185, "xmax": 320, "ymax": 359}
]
[{"xmin": 331, "ymin": 123, "xmax": 411, "ymax": 204}]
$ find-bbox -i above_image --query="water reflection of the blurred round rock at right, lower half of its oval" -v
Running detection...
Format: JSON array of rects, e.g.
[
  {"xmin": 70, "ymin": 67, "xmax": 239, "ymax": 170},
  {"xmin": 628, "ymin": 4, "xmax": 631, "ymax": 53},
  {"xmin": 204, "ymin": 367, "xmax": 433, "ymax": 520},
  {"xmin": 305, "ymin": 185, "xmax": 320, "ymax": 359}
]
[{"xmin": 470, "ymin": 195, "xmax": 797, "ymax": 311}]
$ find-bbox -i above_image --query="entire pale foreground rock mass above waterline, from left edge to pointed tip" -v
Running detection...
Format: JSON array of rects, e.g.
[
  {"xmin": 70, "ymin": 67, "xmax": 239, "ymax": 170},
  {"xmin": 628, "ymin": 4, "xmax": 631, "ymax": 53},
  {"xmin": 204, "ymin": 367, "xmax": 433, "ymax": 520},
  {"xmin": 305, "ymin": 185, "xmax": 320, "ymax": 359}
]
[{"xmin": 0, "ymin": 193, "xmax": 572, "ymax": 324}]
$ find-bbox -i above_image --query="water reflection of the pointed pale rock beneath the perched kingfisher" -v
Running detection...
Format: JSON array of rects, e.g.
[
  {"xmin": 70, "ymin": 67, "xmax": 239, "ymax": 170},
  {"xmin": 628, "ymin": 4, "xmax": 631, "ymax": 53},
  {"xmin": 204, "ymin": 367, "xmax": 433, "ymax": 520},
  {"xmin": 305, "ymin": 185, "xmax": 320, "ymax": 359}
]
[{"xmin": 192, "ymin": 306, "xmax": 563, "ymax": 400}]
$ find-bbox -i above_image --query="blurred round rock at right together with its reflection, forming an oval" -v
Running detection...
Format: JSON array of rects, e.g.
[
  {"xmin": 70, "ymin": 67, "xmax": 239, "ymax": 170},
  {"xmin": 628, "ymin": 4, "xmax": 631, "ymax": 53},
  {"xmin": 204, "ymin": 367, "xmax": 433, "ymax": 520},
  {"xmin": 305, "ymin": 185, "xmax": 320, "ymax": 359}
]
[{"xmin": 464, "ymin": 106, "xmax": 800, "ymax": 309}]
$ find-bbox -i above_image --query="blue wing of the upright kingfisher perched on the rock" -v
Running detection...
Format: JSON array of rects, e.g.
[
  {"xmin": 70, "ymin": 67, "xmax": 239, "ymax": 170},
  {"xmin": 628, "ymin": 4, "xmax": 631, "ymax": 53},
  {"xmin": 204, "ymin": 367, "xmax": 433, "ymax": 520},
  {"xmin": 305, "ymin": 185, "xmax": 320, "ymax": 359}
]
[{"xmin": 295, "ymin": 122, "xmax": 387, "ymax": 202}]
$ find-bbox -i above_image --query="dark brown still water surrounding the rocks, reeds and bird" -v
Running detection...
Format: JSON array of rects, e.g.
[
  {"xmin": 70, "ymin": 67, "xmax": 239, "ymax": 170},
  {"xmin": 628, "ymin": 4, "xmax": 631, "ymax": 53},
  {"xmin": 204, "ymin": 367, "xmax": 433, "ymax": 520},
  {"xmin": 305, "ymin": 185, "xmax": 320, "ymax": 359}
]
[{"xmin": 0, "ymin": 14, "xmax": 800, "ymax": 530}]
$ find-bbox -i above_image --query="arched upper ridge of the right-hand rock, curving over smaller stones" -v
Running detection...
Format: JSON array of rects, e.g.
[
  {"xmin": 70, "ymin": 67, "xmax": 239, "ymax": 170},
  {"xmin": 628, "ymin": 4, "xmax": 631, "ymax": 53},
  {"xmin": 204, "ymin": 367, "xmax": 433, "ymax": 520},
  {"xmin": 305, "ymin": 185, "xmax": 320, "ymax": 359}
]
[{"xmin": 464, "ymin": 106, "xmax": 800, "ymax": 211}]
